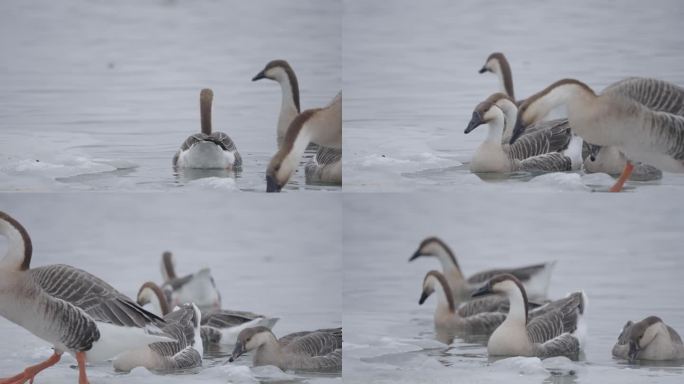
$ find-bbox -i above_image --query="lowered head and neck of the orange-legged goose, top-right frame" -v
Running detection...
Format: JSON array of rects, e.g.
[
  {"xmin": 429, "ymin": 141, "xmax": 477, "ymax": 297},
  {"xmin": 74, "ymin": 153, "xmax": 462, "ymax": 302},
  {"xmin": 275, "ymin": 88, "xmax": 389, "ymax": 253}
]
[{"xmin": 510, "ymin": 79, "xmax": 596, "ymax": 144}]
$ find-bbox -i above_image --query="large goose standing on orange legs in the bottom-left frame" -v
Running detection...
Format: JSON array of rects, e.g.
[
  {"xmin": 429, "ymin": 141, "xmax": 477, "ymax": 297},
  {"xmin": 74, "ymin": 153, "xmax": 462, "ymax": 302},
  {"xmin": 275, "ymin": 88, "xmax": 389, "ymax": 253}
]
[{"xmin": 0, "ymin": 212, "xmax": 174, "ymax": 384}]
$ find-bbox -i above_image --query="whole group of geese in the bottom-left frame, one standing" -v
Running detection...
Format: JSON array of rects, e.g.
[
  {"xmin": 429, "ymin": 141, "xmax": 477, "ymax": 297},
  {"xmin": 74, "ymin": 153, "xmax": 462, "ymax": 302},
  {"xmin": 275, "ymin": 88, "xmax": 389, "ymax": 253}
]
[{"xmin": 0, "ymin": 211, "xmax": 342, "ymax": 384}]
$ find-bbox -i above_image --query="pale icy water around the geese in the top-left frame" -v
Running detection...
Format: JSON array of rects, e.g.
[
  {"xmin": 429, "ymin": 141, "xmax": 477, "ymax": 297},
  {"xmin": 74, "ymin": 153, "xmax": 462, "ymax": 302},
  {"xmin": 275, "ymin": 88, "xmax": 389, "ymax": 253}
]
[{"xmin": 0, "ymin": 0, "xmax": 342, "ymax": 191}]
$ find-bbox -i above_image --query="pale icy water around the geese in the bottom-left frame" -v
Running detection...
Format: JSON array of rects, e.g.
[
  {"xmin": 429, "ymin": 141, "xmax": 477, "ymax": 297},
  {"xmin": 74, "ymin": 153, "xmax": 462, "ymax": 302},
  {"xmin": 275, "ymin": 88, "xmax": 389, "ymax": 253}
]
[{"xmin": 0, "ymin": 191, "xmax": 342, "ymax": 384}]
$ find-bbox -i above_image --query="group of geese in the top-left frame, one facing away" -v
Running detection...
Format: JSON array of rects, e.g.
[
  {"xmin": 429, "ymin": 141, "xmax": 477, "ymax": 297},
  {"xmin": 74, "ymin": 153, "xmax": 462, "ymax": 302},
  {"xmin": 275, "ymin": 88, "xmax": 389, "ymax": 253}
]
[{"xmin": 173, "ymin": 60, "xmax": 342, "ymax": 192}]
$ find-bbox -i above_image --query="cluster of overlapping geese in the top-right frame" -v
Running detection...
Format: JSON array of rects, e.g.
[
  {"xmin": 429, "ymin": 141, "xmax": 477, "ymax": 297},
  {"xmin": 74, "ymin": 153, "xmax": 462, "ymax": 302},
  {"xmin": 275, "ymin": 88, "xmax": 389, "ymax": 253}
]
[{"xmin": 465, "ymin": 52, "xmax": 684, "ymax": 192}]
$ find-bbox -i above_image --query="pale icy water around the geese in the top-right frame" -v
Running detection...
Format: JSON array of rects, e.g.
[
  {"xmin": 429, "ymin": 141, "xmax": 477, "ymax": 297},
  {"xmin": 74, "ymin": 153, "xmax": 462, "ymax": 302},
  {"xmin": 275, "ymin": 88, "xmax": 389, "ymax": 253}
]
[{"xmin": 343, "ymin": 0, "xmax": 684, "ymax": 192}]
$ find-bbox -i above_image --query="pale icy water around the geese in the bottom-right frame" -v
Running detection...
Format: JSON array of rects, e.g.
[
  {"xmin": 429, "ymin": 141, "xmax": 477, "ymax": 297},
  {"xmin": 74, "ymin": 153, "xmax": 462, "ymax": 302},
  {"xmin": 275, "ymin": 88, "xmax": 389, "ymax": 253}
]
[{"xmin": 343, "ymin": 191, "xmax": 684, "ymax": 383}]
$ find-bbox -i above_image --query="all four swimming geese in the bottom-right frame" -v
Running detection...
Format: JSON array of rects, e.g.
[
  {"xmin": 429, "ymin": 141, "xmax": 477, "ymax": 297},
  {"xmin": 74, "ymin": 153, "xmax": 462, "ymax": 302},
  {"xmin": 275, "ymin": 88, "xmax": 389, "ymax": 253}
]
[{"xmin": 409, "ymin": 237, "xmax": 684, "ymax": 361}]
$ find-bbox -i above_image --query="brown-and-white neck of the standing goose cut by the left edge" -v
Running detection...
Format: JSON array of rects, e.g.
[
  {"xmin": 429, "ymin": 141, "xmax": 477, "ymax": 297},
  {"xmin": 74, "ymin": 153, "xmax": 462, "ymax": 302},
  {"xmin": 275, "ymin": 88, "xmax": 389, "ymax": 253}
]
[{"xmin": 0, "ymin": 211, "xmax": 33, "ymax": 271}]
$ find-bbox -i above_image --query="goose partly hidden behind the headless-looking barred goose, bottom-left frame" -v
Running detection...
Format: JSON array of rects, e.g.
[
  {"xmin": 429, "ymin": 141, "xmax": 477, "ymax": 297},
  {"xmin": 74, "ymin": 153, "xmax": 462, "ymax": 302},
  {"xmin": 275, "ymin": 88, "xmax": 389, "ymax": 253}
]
[{"xmin": 137, "ymin": 281, "xmax": 278, "ymax": 345}]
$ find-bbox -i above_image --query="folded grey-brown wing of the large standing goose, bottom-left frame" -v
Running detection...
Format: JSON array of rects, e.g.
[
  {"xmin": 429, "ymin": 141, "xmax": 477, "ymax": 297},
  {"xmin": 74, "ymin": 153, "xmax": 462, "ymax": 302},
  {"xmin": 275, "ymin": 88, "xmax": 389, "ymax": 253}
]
[{"xmin": 28, "ymin": 264, "xmax": 164, "ymax": 328}]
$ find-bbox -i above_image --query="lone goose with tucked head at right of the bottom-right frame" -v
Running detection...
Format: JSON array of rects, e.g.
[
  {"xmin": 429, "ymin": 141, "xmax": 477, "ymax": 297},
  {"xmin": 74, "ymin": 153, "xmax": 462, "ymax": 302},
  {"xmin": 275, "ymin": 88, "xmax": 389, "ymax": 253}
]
[{"xmin": 613, "ymin": 316, "xmax": 684, "ymax": 360}]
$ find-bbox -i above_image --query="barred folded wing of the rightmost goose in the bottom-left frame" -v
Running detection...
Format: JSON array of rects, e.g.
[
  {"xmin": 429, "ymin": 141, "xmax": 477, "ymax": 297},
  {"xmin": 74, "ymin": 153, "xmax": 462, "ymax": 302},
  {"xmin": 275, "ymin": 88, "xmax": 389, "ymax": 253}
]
[{"xmin": 279, "ymin": 328, "xmax": 342, "ymax": 356}]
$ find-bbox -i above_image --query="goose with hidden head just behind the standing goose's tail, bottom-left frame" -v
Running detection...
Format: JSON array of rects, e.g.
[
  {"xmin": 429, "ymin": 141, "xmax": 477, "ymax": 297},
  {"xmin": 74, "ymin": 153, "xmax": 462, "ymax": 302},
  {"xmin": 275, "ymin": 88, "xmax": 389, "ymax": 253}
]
[{"xmin": 112, "ymin": 304, "xmax": 203, "ymax": 373}]
